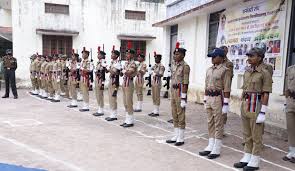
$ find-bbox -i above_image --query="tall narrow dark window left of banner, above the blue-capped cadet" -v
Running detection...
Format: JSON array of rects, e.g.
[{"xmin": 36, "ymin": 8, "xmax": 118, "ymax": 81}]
[{"xmin": 208, "ymin": 10, "xmax": 224, "ymax": 52}]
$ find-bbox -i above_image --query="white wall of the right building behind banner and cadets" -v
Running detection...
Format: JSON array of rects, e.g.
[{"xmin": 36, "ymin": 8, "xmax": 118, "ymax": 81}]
[{"xmin": 164, "ymin": 0, "xmax": 292, "ymax": 128}]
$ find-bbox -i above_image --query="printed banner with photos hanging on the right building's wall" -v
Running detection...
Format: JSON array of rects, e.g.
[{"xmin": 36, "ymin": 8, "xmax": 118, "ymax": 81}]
[{"xmin": 216, "ymin": 0, "xmax": 287, "ymax": 76}]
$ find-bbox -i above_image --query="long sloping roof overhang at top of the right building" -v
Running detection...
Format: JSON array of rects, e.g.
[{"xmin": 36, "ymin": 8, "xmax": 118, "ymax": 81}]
[{"xmin": 153, "ymin": 0, "xmax": 243, "ymax": 27}]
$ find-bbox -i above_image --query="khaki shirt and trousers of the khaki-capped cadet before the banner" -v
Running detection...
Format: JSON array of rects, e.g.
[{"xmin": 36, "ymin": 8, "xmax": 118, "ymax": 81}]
[{"xmin": 241, "ymin": 65, "xmax": 272, "ymax": 156}]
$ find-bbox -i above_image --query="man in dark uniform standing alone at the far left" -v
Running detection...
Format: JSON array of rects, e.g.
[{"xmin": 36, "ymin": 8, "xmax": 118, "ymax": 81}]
[{"xmin": 2, "ymin": 49, "xmax": 18, "ymax": 99}]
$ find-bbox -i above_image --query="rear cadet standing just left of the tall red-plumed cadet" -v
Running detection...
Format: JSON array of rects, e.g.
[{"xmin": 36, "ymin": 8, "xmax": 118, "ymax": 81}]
[{"xmin": 148, "ymin": 52, "xmax": 165, "ymax": 117}]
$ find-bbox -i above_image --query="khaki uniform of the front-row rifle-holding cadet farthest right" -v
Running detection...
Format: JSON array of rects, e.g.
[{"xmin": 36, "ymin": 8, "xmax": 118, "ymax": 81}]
[{"xmin": 122, "ymin": 60, "xmax": 137, "ymax": 115}]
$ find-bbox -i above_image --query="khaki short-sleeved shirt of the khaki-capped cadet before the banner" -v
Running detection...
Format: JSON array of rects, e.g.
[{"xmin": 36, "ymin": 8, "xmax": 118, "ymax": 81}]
[{"xmin": 242, "ymin": 64, "xmax": 272, "ymax": 93}]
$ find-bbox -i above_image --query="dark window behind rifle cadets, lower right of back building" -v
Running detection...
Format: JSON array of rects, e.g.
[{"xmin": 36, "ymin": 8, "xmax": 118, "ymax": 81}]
[{"xmin": 120, "ymin": 40, "xmax": 147, "ymax": 61}]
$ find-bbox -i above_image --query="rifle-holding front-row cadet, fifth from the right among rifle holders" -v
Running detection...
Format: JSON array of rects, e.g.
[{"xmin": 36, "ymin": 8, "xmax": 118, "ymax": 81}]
[{"xmin": 68, "ymin": 50, "xmax": 80, "ymax": 108}]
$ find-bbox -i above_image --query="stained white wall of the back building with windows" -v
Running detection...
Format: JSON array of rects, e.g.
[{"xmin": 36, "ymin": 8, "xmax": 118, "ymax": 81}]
[{"xmin": 12, "ymin": 0, "xmax": 165, "ymax": 86}]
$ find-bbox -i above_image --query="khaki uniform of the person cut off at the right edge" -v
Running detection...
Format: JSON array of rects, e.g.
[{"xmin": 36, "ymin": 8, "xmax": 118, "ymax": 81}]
[{"xmin": 285, "ymin": 65, "xmax": 295, "ymax": 148}]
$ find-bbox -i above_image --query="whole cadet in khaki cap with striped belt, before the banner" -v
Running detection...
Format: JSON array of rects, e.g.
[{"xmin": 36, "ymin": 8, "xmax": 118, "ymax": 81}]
[{"xmin": 234, "ymin": 47, "xmax": 272, "ymax": 171}]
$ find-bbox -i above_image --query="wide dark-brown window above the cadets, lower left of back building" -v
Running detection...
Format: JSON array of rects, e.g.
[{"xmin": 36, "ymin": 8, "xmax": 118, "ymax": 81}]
[{"xmin": 42, "ymin": 35, "xmax": 72, "ymax": 56}]
